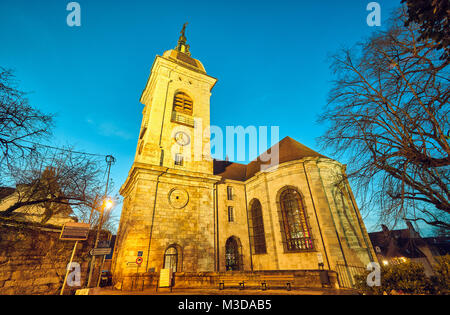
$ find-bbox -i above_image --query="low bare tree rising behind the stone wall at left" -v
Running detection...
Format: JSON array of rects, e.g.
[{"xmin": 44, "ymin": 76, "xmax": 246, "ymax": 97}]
[{"xmin": 0, "ymin": 148, "xmax": 104, "ymax": 223}]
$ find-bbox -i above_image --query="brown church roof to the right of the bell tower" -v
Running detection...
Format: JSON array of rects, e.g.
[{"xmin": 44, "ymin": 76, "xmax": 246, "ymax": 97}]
[{"xmin": 214, "ymin": 137, "xmax": 327, "ymax": 181}]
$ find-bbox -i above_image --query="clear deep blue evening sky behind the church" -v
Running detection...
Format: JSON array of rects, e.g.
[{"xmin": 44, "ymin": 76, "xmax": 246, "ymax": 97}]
[{"xmin": 0, "ymin": 0, "xmax": 408, "ymax": 235}]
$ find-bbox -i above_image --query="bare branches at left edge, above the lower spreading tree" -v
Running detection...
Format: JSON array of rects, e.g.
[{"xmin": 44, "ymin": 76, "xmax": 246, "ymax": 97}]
[{"xmin": 0, "ymin": 67, "xmax": 53, "ymax": 169}]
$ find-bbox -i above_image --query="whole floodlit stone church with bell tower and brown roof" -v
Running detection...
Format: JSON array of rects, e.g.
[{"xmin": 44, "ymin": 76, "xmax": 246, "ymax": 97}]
[{"xmin": 112, "ymin": 27, "xmax": 376, "ymax": 290}]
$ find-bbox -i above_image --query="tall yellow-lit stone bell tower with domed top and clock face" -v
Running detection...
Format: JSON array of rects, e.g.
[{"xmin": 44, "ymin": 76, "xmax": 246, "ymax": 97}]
[{"xmin": 112, "ymin": 24, "xmax": 220, "ymax": 281}]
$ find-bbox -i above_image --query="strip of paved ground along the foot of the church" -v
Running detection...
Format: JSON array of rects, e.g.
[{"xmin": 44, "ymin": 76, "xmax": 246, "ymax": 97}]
[{"xmin": 90, "ymin": 288, "xmax": 357, "ymax": 295}]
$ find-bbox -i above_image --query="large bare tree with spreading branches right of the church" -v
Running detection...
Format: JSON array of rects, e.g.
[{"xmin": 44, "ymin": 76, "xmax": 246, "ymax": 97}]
[{"xmin": 319, "ymin": 8, "xmax": 450, "ymax": 229}]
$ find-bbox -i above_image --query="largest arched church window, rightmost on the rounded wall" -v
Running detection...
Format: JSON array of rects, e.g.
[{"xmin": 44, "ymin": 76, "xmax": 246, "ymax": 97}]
[{"xmin": 280, "ymin": 188, "xmax": 313, "ymax": 251}]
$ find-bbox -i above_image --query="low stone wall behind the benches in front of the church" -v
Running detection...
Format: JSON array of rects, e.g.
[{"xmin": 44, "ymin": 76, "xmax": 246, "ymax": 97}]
[{"xmin": 115, "ymin": 270, "xmax": 339, "ymax": 291}]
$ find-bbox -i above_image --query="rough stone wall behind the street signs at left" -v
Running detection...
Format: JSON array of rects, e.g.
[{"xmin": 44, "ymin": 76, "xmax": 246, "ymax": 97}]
[{"xmin": 0, "ymin": 220, "xmax": 107, "ymax": 295}]
